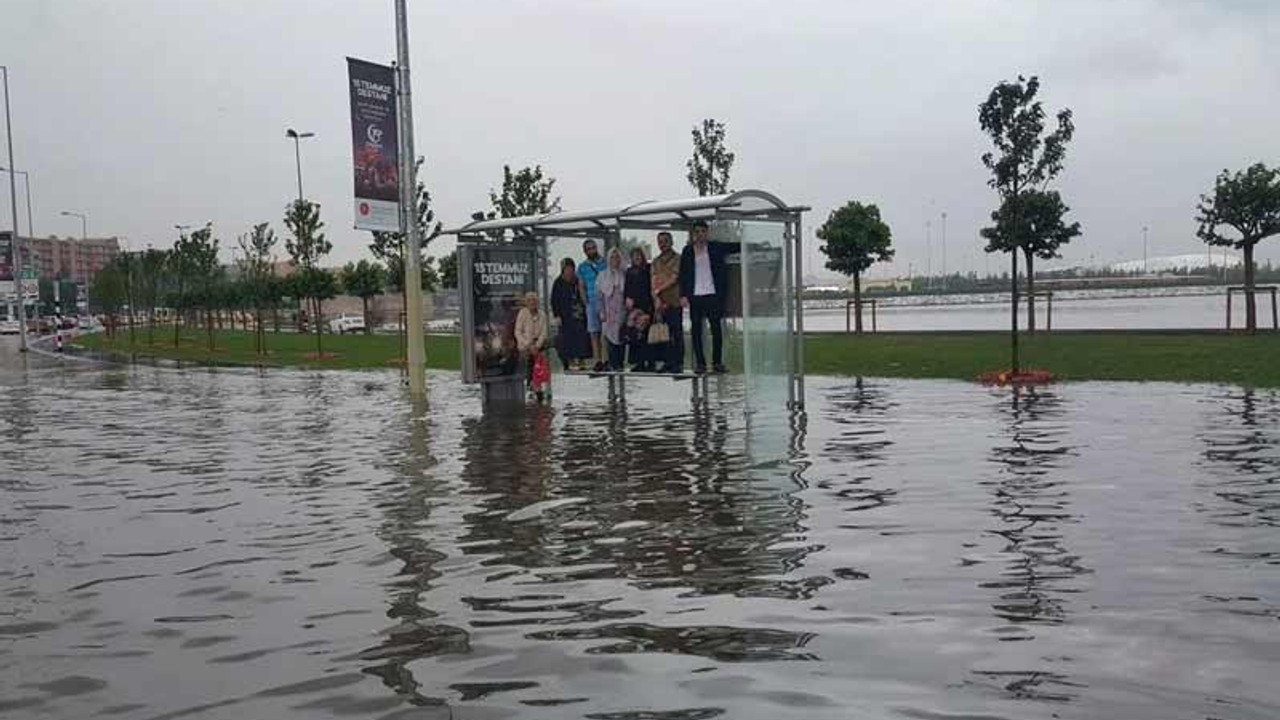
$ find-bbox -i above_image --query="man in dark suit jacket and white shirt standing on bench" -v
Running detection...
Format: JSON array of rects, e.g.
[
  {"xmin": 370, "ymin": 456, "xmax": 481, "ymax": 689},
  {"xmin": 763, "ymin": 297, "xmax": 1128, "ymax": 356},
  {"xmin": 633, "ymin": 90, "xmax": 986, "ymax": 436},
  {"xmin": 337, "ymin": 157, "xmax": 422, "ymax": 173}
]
[{"xmin": 680, "ymin": 220, "xmax": 728, "ymax": 374}]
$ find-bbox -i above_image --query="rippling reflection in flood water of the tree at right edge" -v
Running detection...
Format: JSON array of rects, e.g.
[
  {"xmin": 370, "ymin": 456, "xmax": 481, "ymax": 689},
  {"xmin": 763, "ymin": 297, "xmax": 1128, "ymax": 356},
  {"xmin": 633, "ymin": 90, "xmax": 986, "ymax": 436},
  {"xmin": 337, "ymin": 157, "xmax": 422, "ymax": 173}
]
[{"xmin": 1201, "ymin": 388, "xmax": 1280, "ymax": 532}]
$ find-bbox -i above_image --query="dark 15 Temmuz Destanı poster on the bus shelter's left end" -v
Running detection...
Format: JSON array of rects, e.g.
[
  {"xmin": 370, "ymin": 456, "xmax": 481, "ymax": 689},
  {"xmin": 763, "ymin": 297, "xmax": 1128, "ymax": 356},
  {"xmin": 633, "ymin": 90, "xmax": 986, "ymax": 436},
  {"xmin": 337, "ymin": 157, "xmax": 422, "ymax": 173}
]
[{"xmin": 458, "ymin": 245, "xmax": 538, "ymax": 383}]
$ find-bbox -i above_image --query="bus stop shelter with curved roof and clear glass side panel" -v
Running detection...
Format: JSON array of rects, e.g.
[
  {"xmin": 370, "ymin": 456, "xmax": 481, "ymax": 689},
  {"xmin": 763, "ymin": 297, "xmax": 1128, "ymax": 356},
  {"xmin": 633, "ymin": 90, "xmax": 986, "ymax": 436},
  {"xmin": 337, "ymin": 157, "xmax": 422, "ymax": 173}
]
[{"xmin": 445, "ymin": 190, "xmax": 809, "ymax": 409}]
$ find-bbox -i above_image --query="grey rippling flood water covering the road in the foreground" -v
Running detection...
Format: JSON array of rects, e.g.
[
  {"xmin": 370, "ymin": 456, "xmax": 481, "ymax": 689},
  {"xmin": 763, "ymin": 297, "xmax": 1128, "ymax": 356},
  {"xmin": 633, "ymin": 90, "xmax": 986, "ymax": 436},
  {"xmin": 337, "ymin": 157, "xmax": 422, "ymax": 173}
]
[{"xmin": 0, "ymin": 343, "xmax": 1280, "ymax": 720}]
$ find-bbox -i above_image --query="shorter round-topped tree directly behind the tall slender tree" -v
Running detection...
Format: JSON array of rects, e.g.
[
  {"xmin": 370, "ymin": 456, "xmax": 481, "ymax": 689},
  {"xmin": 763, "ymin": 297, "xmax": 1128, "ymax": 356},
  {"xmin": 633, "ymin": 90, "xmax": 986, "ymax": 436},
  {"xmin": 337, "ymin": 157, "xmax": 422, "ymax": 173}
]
[{"xmin": 979, "ymin": 190, "xmax": 1080, "ymax": 332}]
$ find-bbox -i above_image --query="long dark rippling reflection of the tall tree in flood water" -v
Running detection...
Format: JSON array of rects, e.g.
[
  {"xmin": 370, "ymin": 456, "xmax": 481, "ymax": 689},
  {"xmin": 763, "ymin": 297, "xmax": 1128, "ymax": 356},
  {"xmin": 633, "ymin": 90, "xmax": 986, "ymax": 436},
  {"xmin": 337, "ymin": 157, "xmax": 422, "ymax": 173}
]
[{"xmin": 982, "ymin": 388, "xmax": 1087, "ymax": 624}]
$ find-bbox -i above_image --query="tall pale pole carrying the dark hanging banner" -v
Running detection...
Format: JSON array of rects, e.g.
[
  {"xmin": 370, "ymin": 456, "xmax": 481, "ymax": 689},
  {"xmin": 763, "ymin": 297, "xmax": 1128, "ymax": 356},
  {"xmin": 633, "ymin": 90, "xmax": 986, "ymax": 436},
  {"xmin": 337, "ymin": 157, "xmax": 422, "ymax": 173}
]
[{"xmin": 396, "ymin": 0, "xmax": 426, "ymax": 397}]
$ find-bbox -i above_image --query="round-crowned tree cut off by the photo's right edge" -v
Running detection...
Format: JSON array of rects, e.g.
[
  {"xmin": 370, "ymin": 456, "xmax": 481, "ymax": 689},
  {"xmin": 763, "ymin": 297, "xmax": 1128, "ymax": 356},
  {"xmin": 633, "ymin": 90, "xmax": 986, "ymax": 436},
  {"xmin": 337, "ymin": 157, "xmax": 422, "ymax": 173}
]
[{"xmin": 1196, "ymin": 163, "xmax": 1280, "ymax": 333}]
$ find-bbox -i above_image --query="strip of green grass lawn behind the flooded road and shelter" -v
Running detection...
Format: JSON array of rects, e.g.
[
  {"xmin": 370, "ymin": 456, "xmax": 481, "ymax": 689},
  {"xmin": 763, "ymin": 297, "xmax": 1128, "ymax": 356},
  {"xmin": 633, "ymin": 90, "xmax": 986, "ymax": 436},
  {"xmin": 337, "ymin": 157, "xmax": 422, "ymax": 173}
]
[{"xmin": 76, "ymin": 329, "xmax": 1280, "ymax": 387}]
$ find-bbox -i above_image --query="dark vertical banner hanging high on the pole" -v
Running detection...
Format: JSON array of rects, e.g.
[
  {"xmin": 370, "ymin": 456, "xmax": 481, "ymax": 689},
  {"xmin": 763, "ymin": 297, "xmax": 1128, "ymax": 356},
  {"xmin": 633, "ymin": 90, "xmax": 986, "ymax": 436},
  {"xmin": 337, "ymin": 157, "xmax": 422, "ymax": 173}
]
[{"xmin": 347, "ymin": 58, "xmax": 401, "ymax": 232}]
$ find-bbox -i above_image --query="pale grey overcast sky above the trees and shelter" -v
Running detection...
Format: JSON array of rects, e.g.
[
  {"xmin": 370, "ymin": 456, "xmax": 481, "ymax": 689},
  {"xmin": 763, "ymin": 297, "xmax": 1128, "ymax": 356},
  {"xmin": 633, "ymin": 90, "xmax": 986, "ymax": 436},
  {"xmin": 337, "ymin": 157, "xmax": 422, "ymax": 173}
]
[{"xmin": 0, "ymin": 0, "xmax": 1280, "ymax": 274}]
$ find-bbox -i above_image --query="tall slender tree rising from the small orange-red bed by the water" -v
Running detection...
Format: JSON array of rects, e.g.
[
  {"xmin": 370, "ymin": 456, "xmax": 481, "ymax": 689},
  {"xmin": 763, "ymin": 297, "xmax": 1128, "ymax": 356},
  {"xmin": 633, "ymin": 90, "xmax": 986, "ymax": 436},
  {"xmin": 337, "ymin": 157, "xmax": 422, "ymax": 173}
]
[{"xmin": 978, "ymin": 76, "xmax": 1075, "ymax": 373}]
